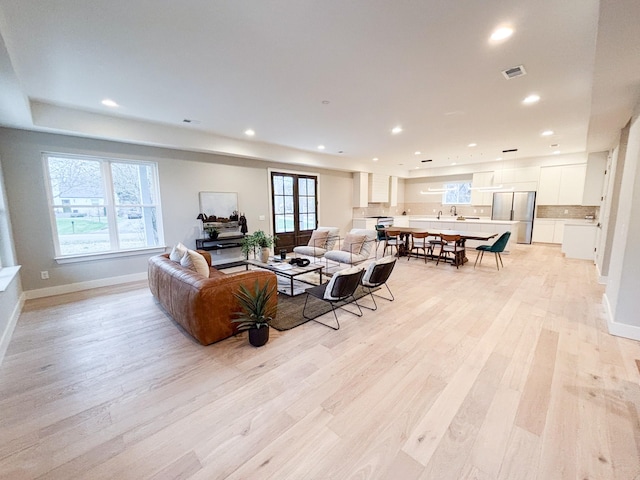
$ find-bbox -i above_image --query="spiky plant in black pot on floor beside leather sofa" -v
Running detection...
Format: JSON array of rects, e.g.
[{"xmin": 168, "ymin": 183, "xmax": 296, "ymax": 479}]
[{"xmin": 232, "ymin": 280, "xmax": 277, "ymax": 347}]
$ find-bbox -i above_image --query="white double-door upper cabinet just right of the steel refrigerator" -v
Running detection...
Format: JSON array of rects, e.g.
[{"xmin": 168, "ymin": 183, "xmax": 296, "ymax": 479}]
[{"xmin": 536, "ymin": 163, "xmax": 587, "ymax": 205}]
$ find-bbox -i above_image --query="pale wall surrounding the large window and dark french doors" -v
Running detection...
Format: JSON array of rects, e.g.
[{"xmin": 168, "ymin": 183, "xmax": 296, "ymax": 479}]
[{"xmin": 0, "ymin": 129, "xmax": 353, "ymax": 291}]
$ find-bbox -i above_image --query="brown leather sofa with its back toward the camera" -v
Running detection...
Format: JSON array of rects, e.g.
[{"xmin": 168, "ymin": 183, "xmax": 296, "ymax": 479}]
[{"xmin": 148, "ymin": 250, "xmax": 278, "ymax": 345}]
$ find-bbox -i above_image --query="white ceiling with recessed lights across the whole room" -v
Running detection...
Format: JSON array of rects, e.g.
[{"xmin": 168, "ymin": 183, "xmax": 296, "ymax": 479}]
[{"xmin": 0, "ymin": 0, "xmax": 640, "ymax": 176}]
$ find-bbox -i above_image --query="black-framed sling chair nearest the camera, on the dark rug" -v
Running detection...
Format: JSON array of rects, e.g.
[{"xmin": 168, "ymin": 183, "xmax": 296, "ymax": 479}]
[{"xmin": 302, "ymin": 267, "xmax": 364, "ymax": 330}]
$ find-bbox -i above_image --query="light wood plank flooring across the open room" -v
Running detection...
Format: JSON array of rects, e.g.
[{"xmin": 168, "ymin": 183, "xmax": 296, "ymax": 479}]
[{"xmin": 0, "ymin": 245, "xmax": 640, "ymax": 480}]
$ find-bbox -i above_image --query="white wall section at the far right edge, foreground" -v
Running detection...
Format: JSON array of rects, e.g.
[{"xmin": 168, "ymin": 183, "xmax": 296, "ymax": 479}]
[{"xmin": 605, "ymin": 104, "xmax": 640, "ymax": 340}]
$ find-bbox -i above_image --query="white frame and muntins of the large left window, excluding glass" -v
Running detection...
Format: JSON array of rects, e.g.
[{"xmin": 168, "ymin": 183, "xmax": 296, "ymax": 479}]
[{"xmin": 42, "ymin": 152, "xmax": 166, "ymax": 263}]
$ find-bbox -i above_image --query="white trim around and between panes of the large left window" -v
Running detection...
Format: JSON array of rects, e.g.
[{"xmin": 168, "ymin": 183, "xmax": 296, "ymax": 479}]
[{"xmin": 42, "ymin": 152, "xmax": 166, "ymax": 258}]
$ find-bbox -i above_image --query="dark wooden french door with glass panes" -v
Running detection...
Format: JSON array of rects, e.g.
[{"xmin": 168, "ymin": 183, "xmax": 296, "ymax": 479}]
[{"xmin": 271, "ymin": 172, "xmax": 318, "ymax": 254}]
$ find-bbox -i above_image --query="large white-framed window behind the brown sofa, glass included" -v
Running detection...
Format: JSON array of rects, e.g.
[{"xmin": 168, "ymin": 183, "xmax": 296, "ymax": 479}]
[{"xmin": 44, "ymin": 154, "xmax": 164, "ymax": 257}]
